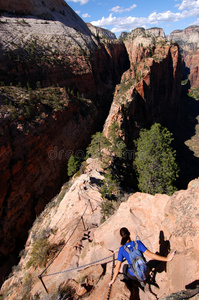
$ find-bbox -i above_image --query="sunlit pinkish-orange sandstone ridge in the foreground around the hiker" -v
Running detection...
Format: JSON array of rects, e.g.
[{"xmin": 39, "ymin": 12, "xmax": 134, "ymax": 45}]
[{"xmin": 1, "ymin": 159, "xmax": 199, "ymax": 300}]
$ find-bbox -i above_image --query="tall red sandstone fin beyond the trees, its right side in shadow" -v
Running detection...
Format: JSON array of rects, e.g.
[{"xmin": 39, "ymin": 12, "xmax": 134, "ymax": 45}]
[{"xmin": 104, "ymin": 29, "xmax": 181, "ymax": 145}]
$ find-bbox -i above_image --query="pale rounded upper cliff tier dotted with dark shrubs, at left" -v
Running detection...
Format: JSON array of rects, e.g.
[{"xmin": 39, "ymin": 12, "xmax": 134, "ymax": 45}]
[{"xmin": 0, "ymin": 17, "xmax": 128, "ymax": 102}]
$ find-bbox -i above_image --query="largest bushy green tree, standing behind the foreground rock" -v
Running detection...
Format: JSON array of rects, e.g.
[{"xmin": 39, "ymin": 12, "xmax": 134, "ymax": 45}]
[{"xmin": 134, "ymin": 123, "xmax": 179, "ymax": 195}]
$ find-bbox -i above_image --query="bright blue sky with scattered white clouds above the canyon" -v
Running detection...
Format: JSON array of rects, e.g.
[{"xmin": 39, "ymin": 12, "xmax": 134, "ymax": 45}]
[{"xmin": 66, "ymin": 0, "xmax": 199, "ymax": 37}]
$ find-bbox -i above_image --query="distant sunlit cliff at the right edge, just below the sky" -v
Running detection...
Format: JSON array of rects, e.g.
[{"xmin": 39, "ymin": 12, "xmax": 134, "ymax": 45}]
[{"xmin": 168, "ymin": 25, "xmax": 199, "ymax": 88}]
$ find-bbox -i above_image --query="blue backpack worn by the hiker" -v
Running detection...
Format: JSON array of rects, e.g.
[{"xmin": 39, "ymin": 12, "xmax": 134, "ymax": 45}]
[{"xmin": 123, "ymin": 237, "xmax": 148, "ymax": 281}]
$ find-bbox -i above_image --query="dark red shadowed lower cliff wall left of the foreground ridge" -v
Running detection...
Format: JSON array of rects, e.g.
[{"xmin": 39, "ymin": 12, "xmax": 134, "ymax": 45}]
[{"xmin": 0, "ymin": 99, "xmax": 98, "ymax": 284}]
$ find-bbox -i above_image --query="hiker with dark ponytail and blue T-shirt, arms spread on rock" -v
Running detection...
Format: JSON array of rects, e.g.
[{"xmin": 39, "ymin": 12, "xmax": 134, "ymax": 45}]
[{"xmin": 109, "ymin": 227, "xmax": 175, "ymax": 286}]
